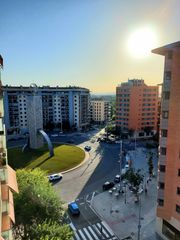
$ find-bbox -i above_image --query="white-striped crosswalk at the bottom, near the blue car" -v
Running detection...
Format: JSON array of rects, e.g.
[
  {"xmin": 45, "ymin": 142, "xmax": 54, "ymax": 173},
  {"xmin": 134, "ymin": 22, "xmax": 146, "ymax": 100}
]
[{"xmin": 73, "ymin": 221, "xmax": 118, "ymax": 240}]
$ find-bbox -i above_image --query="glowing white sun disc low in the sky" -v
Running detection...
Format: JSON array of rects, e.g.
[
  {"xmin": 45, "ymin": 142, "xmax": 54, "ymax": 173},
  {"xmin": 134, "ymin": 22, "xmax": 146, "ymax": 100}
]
[{"xmin": 127, "ymin": 27, "xmax": 157, "ymax": 58}]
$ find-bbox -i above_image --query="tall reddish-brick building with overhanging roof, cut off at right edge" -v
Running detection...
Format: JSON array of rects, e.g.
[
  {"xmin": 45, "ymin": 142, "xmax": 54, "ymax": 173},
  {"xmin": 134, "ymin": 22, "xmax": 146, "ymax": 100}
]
[{"xmin": 152, "ymin": 42, "xmax": 180, "ymax": 240}]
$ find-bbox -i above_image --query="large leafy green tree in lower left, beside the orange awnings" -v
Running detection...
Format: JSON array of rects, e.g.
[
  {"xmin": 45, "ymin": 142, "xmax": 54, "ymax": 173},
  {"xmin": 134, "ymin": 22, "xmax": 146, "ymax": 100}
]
[{"xmin": 14, "ymin": 169, "xmax": 72, "ymax": 240}]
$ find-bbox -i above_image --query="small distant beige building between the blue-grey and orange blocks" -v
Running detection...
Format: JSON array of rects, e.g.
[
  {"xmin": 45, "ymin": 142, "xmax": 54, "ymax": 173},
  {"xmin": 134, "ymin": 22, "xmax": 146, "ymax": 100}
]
[{"xmin": 90, "ymin": 99, "xmax": 111, "ymax": 124}]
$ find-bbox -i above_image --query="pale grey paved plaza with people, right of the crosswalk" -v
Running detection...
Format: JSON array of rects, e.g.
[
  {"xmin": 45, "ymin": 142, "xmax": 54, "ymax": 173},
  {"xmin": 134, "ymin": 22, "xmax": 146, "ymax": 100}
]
[{"xmin": 91, "ymin": 147, "xmax": 158, "ymax": 240}]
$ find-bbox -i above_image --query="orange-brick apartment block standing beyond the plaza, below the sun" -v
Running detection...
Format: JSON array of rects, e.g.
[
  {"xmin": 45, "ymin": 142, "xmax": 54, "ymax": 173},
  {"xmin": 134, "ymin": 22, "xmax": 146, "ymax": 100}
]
[{"xmin": 116, "ymin": 79, "xmax": 158, "ymax": 136}]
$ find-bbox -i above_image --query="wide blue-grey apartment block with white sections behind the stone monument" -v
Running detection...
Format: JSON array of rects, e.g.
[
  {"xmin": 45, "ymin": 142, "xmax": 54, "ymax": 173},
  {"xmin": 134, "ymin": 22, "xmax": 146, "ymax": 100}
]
[{"xmin": 3, "ymin": 84, "xmax": 90, "ymax": 137}]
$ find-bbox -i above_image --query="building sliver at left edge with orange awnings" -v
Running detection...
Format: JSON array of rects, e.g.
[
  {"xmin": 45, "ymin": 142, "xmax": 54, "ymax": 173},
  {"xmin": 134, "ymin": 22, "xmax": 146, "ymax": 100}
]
[{"xmin": 0, "ymin": 56, "xmax": 18, "ymax": 240}]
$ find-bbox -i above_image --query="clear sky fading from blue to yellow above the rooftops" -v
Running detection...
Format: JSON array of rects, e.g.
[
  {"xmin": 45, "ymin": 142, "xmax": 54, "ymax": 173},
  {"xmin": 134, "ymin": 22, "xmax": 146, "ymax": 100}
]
[{"xmin": 0, "ymin": 0, "xmax": 180, "ymax": 94}]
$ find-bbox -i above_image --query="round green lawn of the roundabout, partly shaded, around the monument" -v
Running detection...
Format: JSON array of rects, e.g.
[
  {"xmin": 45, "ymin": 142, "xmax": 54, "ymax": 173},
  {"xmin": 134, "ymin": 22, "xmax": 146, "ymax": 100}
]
[{"xmin": 8, "ymin": 145, "xmax": 85, "ymax": 173}]
